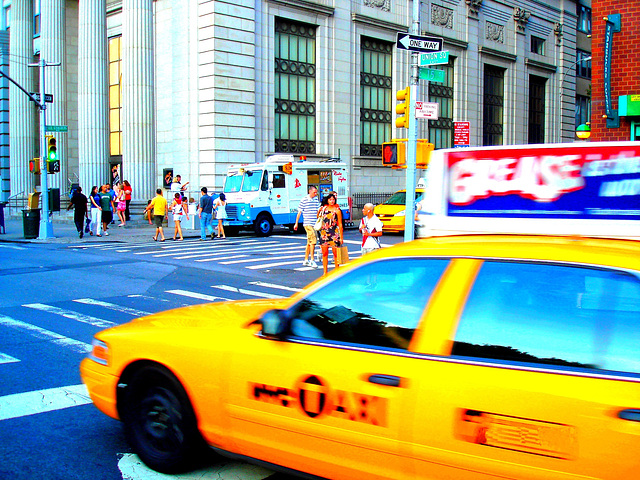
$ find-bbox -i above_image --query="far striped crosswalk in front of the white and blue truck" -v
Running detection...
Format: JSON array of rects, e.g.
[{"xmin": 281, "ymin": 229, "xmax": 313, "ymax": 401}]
[{"xmin": 69, "ymin": 236, "xmax": 360, "ymax": 271}]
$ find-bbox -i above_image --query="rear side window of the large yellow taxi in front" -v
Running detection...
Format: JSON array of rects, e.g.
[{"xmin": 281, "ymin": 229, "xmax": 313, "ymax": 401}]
[{"xmin": 452, "ymin": 262, "xmax": 640, "ymax": 374}]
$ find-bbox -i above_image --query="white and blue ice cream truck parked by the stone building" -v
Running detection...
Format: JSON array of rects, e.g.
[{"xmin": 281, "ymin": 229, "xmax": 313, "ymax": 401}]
[{"xmin": 223, "ymin": 155, "xmax": 351, "ymax": 236}]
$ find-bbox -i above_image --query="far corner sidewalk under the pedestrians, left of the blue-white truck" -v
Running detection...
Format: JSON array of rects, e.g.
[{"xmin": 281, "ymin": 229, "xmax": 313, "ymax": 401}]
[{"xmin": 0, "ymin": 214, "xmax": 200, "ymax": 244}]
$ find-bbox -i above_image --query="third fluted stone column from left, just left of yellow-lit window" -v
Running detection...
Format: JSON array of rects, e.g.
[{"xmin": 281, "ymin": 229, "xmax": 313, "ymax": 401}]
[{"xmin": 78, "ymin": 0, "xmax": 109, "ymax": 193}]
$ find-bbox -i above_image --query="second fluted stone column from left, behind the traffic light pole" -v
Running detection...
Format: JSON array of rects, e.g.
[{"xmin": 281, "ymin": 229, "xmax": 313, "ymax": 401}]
[{"xmin": 40, "ymin": 0, "xmax": 66, "ymax": 194}]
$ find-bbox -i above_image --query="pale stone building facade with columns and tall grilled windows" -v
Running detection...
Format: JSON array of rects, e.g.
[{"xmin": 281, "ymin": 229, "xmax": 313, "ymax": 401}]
[{"xmin": 0, "ymin": 0, "xmax": 584, "ymax": 204}]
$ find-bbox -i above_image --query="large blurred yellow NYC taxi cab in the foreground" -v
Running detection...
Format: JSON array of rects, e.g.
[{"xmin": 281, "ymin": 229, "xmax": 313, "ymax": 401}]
[{"xmin": 81, "ymin": 235, "xmax": 640, "ymax": 480}]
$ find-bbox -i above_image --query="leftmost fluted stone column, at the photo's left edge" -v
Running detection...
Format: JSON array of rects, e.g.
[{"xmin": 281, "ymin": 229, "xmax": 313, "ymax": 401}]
[{"xmin": 9, "ymin": 0, "xmax": 39, "ymax": 195}]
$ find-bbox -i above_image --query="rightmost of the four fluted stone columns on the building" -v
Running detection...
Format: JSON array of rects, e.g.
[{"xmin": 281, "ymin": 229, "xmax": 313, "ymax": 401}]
[{"xmin": 122, "ymin": 0, "xmax": 161, "ymax": 199}]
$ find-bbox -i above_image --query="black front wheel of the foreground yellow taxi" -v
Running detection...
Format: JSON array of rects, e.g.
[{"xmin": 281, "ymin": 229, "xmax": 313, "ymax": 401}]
[{"xmin": 122, "ymin": 367, "xmax": 204, "ymax": 473}]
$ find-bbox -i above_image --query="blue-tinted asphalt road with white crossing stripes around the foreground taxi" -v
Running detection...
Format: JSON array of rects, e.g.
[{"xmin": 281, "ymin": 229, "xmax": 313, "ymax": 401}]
[{"xmin": 0, "ymin": 231, "xmax": 402, "ymax": 480}]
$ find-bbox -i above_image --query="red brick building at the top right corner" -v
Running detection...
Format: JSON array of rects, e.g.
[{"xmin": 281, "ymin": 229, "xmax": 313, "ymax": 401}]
[{"xmin": 591, "ymin": 0, "xmax": 640, "ymax": 141}]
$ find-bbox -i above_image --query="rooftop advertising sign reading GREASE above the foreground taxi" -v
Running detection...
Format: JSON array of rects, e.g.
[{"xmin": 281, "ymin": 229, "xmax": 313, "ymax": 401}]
[{"xmin": 417, "ymin": 142, "xmax": 640, "ymax": 238}]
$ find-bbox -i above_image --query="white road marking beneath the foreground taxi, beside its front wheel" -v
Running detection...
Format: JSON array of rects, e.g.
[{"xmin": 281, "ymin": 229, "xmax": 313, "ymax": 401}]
[{"xmin": 118, "ymin": 453, "xmax": 274, "ymax": 480}]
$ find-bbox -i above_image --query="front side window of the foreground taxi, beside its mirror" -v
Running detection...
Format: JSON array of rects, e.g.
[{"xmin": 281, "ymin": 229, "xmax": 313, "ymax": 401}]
[{"xmin": 291, "ymin": 258, "xmax": 449, "ymax": 350}]
